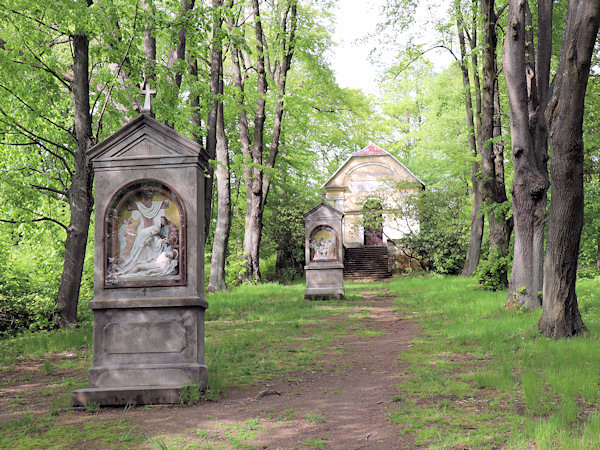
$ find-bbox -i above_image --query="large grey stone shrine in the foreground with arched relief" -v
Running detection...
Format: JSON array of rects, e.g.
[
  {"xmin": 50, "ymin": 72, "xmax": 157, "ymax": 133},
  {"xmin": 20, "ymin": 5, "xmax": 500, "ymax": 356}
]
[{"xmin": 71, "ymin": 109, "xmax": 208, "ymax": 406}]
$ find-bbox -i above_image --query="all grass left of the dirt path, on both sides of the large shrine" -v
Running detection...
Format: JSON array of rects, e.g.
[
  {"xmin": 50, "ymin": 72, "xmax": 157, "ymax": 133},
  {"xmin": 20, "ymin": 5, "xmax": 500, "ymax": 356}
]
[{"xmin": 0, "ymin": 284, "xmax": 368, "ymax": 448}]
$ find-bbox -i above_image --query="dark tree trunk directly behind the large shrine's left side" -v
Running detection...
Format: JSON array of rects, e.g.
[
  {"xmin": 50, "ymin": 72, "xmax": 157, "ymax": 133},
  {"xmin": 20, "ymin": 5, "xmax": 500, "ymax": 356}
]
[{"xmin": 56, "ymin": 35, "xmax": 94, "ymax": 327}]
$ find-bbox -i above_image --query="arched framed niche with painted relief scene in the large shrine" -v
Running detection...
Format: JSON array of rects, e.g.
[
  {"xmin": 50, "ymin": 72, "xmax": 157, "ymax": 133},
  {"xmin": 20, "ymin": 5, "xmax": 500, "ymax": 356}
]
[{"xmin": 105, "ymin": 181, "xmax": 185, "ymax": 287}]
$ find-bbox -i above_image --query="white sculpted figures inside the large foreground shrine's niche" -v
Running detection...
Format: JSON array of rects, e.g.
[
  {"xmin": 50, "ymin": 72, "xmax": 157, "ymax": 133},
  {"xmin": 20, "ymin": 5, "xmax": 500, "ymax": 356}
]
[{"xmin": 116, "ymin": 200, "xmax": 179, "ymax": 278}]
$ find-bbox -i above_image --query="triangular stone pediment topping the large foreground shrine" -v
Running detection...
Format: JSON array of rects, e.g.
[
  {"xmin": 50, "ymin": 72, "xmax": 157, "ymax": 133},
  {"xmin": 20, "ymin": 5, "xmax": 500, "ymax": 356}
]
[{"xmin": 88, "ymin": 115, "xmax": 208, "ymax": 165}]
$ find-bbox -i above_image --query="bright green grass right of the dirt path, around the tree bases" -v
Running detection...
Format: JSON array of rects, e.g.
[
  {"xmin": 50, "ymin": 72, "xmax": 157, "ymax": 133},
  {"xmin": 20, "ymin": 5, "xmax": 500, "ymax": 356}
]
[{"xmin": 387, "ymin": 276, "xmax": 600, "ymax": 448}]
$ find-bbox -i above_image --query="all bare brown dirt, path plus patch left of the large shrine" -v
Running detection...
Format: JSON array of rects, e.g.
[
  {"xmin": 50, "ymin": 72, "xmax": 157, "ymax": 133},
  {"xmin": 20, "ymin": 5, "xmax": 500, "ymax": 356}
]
[{"xmin": 0, "ymin": 293, "xmax": 419, "ymax": 449}]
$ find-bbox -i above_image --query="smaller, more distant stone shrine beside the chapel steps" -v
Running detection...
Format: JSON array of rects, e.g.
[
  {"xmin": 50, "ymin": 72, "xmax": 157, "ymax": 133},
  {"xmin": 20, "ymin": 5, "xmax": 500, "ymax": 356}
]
[{"xmin": 304, "ymin": 202, "xmax": 344, "ymax": 299}]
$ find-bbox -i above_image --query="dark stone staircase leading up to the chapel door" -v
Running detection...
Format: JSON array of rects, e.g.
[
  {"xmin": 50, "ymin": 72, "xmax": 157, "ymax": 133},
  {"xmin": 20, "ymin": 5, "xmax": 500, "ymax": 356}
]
[{"xmin": 344, "ymin": 246, "xmax": 392, "ymax": 280}]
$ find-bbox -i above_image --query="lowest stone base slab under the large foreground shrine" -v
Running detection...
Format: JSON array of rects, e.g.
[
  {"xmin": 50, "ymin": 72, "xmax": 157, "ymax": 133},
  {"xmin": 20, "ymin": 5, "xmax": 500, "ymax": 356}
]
[{"xmin": 71, "ymin": 386, "xmax": 182, "ymax": 407}]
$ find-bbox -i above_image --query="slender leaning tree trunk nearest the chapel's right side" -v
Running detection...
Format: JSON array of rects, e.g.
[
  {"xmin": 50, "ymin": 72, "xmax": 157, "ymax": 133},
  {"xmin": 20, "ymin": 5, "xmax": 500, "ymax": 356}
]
[{"xmin": 456, "ymin": 8, "xmax": 484, "ymax": 277}]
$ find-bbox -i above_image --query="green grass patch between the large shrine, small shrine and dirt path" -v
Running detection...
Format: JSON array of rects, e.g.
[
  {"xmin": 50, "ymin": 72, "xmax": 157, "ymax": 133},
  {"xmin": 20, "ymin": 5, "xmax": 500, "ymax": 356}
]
[{"xmin": 206, "ymin": 283, "xmax": 368, "ymax": 398}]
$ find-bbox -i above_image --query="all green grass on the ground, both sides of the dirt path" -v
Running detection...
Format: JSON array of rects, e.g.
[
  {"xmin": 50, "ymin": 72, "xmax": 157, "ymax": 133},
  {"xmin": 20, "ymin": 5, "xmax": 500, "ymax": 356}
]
[{"xmin": 0, "ymin": 276, "xmax": 600, "ymax": 449}]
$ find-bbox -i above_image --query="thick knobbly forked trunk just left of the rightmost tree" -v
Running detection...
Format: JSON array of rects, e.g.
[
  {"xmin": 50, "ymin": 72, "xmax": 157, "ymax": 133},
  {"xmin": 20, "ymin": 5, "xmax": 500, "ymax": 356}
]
[{"xmin": 503, "ymin": 0, "xmax": 552, "ymax": 310}]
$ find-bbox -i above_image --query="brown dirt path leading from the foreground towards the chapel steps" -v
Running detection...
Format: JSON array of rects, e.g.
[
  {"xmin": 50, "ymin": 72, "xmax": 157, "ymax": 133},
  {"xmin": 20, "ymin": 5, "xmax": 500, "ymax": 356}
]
[{"xmin": 121, "ymin": 294, "xmax": 418, "ymax": 449}]
